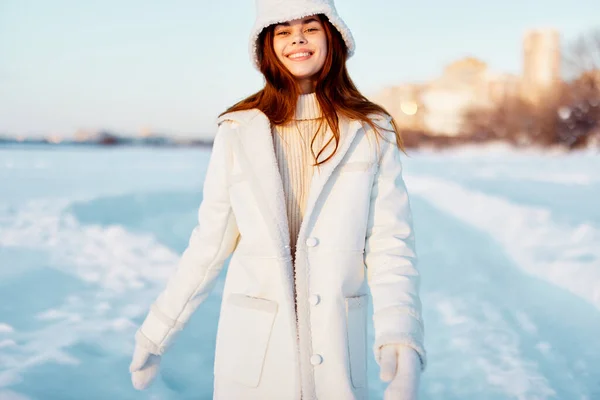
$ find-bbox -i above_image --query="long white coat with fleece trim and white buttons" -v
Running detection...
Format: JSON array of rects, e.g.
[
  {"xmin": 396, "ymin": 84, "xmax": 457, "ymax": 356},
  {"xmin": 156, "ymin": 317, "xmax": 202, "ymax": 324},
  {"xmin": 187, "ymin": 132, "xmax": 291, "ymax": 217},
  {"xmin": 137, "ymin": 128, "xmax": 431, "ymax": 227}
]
[{"xmin": 136, "ymin": 109, "xmax": 426, "ymax": 400}]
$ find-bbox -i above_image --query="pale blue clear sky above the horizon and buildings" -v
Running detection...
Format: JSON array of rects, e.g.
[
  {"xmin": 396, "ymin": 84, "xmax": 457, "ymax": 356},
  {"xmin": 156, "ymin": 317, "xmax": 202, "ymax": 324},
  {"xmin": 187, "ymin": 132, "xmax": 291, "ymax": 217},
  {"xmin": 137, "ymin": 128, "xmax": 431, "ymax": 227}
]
[{"xmin": 0, "ymin": 0, "xmax": 600, "ymax": 137}]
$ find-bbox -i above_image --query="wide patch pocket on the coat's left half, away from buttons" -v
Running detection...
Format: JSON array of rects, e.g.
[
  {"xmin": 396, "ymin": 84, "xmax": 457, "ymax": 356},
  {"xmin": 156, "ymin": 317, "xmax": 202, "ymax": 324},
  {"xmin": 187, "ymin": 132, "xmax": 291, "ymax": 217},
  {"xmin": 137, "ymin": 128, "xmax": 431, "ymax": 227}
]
[{"xmin": 216, "ymin": 293, "xmax": 277, "ymax": 387}]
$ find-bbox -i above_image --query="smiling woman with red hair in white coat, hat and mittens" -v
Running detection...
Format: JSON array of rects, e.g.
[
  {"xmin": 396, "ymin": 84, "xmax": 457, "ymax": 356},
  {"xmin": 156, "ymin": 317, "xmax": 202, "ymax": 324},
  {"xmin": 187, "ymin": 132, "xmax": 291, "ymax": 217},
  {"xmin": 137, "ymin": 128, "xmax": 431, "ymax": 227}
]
[{"xmin": 130, "ymin": 0, "xmax": 426, "ymax": 400}]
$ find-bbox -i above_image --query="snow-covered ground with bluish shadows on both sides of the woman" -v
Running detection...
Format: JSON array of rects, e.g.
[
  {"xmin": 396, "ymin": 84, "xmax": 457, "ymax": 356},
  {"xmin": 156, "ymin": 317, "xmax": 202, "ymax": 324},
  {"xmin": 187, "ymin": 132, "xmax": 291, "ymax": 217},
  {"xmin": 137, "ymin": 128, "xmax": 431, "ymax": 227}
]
[{"xmin": 0, "ymin": 148, "xmax": 600, "ymax": 400}]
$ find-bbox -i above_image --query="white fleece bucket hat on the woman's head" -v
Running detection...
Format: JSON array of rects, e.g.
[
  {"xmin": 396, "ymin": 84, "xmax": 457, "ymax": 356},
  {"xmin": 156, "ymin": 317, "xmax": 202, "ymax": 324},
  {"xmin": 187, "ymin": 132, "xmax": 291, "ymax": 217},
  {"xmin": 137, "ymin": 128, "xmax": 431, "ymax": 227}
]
[{"xmin": 249, "ymin": 0, "xmax": 355, "ymax": 69}]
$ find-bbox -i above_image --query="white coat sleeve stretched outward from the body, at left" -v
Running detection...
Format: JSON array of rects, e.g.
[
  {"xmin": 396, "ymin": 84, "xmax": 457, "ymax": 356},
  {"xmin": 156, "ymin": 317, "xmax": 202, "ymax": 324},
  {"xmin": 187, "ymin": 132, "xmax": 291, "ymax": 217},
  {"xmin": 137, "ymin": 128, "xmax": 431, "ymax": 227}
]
[{"xmin": 135, "ymin": 123, "xmax": 239, "ymax": 355}]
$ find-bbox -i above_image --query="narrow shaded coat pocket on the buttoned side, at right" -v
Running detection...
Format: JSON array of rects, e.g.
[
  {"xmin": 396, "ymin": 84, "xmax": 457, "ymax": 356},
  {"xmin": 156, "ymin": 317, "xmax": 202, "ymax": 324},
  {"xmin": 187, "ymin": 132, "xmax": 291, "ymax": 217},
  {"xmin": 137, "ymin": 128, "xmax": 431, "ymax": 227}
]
[{"xmin": 346, "ymin": 294, "xmax": 369, "ymax": 388}]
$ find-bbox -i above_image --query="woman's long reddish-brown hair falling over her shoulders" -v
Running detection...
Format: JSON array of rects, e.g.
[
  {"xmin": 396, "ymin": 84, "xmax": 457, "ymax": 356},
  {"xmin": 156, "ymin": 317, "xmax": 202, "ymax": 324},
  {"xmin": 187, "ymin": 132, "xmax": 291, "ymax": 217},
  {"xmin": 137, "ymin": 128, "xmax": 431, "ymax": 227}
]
[{"xmin": 220, "ymin": 14, "xmax": 404, "ymax": 165}]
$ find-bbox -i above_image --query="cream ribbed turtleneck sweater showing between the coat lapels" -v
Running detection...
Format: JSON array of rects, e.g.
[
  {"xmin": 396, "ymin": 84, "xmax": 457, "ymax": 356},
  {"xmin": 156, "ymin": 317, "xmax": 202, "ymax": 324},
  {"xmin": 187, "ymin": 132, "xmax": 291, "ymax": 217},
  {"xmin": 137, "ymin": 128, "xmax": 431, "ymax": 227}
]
[{"xmin": 272, "ymin": 93, "xmax": 329, "ymax": 257}]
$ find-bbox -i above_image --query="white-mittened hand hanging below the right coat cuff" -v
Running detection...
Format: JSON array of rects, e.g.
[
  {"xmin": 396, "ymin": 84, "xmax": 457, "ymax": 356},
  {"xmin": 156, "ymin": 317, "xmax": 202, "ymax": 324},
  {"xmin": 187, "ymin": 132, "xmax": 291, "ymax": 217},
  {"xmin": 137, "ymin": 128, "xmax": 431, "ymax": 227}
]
[{"xmin": 379, "ymin": 344, "xmax": 421, "ymax": 400}]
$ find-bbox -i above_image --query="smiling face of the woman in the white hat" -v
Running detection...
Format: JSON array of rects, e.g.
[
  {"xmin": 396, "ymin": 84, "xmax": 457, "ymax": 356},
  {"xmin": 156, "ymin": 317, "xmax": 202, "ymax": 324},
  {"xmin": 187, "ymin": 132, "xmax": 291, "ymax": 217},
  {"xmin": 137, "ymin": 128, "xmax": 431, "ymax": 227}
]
[{"xmin": 273, "ymin": 16, "xmax": 327, "ymax": 92}]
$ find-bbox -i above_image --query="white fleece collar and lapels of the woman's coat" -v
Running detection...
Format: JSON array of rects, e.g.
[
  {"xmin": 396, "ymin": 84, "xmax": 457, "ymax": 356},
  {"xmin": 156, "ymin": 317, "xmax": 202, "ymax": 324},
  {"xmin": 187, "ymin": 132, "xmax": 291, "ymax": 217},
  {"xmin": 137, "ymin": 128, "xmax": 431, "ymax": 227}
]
[{"xmin": 217, "ymin": 109, "xmax": 362, "ymax": 256}]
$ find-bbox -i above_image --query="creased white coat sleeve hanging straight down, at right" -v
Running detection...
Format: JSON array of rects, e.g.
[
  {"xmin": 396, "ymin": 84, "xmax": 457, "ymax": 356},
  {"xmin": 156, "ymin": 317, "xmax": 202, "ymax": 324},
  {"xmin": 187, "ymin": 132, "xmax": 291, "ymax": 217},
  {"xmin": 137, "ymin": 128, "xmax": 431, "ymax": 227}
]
[{"xmin": 365, "ymin": 117, "xmax": 426, "ymax": 369}]
